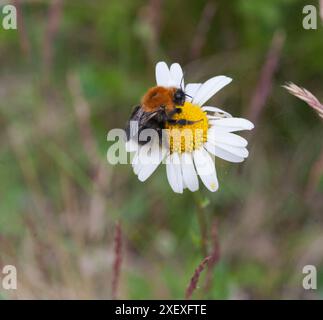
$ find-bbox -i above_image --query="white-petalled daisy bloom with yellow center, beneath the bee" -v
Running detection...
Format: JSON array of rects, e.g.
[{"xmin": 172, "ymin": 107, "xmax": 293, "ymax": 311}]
[{"xmin": 126, "ymin": 62, "xmax": 254, "ymax": 193}]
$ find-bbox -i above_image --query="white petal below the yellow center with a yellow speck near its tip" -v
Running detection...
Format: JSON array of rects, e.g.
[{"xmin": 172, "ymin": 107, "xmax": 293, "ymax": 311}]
[{"xmin": 193, "ymin": 148, "xmax": 219, "ymax": 192}]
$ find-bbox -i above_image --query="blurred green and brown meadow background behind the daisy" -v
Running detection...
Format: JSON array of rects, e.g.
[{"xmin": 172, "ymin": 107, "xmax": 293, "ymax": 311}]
[{"xmin": 0, "ymin": 0, "xmax": 323, "ymax": 299}]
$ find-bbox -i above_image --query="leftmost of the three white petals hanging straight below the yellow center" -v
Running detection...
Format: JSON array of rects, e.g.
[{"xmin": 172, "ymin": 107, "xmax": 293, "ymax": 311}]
[{"xmin": 166, "ymin": 153, "xmax": 183, "ymax": 193}]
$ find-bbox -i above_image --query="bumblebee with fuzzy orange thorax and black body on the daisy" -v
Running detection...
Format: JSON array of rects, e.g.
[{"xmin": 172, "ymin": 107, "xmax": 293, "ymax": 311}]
[{"xmin": 126, "ymin": 86, "xmax": 196, "ymax": 145}]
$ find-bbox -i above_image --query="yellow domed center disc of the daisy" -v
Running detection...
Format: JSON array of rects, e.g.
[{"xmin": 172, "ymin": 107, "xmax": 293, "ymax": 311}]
[{"xmin": 166, "ymin": 102, "xmax": 209, "ymax": 153}]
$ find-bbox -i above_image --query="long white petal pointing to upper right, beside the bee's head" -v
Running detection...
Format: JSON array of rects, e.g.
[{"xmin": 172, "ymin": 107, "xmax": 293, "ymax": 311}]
[{"xmin": 193, "ymin": 76, "xmax": 232, "ymax": 106}]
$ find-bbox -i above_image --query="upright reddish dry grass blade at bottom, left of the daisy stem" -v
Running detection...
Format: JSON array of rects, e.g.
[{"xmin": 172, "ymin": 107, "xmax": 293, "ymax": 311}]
[{"xmin": 112, "ymin": 222, "xmax": 122, "ymax": 300}]
